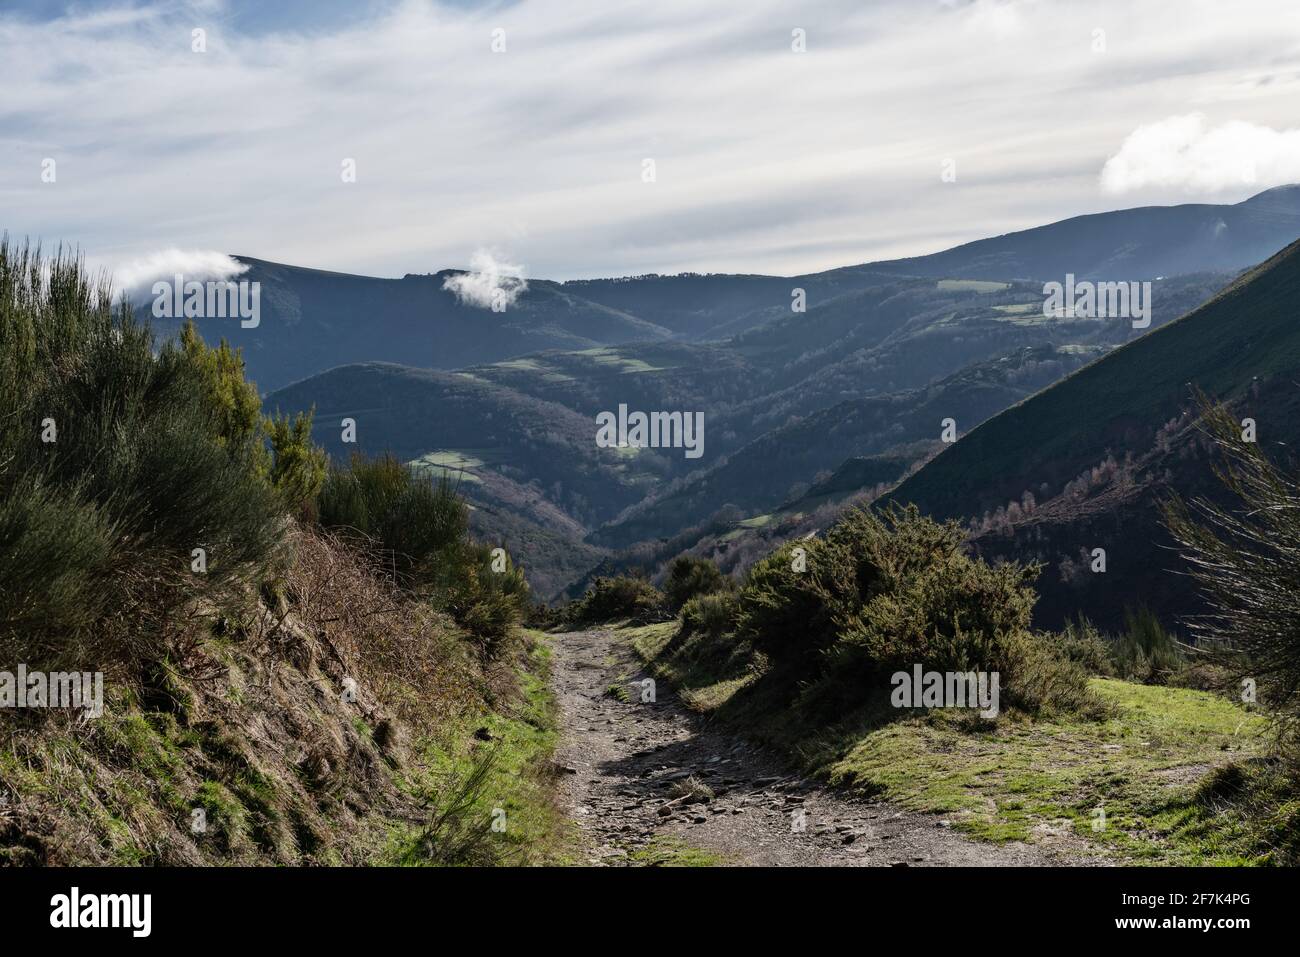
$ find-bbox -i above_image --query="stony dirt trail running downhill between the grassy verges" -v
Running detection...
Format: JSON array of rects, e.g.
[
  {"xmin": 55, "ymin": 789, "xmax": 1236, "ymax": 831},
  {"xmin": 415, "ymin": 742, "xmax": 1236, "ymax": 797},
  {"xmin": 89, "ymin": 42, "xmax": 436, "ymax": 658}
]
[{"xmin": 553, "ymin": 629, "xmax": 1097, "ymax": 867}]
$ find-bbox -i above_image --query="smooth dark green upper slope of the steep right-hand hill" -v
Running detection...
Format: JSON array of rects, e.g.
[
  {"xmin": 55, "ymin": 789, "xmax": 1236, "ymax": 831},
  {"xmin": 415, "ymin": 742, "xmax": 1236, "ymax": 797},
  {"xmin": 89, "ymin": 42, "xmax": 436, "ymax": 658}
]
[{"xmin": 891, "ymin": 237, "xmax": 1300, "ymax": 518}]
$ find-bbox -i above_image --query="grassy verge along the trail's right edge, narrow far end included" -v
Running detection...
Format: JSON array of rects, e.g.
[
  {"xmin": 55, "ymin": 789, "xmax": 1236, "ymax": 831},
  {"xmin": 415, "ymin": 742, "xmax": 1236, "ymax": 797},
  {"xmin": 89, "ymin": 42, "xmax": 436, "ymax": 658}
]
[{"xmin": 624, "ymin": 623, "xmax": 1274, "ymax": 865}]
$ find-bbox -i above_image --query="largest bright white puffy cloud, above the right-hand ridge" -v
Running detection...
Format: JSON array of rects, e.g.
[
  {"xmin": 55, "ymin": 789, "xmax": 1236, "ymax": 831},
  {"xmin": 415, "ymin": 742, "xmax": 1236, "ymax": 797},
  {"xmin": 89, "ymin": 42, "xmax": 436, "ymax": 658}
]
[{"xmin": 1101, "ymin": 113, "xmax": 1300, "ymax": 194}]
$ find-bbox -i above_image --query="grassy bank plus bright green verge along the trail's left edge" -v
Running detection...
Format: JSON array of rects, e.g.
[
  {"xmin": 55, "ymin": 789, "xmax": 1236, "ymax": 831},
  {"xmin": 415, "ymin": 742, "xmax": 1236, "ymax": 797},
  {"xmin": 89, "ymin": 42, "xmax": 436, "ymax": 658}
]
[{"xmin": 0, "ymin": 621, "xmax": 567, "ymax": 866}]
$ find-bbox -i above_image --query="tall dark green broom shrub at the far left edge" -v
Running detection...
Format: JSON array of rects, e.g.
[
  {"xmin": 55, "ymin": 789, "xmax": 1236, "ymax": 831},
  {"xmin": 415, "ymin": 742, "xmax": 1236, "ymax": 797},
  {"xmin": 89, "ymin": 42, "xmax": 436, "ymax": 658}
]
[{"xmin": 0, "ymin": 239, "xmax": 283, "ymax": 668}]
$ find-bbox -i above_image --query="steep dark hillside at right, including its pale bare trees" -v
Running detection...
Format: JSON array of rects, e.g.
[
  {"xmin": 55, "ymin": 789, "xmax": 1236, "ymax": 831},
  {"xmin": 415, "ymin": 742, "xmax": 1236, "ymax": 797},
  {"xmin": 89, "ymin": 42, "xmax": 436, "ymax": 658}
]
[{"xmin": 885, "ymin": 242, "xmax": 1300, "ymax": 627}]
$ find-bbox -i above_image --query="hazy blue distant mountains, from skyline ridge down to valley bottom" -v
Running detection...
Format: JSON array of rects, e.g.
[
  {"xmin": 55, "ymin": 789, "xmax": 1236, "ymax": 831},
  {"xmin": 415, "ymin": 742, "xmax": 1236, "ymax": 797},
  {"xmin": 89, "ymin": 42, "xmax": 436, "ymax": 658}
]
[{"xmin": 228, "ymin": 187, "xmax": 1300, "ymax": 600}]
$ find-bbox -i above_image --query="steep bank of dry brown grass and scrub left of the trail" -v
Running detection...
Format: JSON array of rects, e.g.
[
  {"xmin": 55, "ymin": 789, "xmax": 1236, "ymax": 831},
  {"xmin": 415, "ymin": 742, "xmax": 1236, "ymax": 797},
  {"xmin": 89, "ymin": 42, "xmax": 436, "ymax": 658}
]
[{"xmin": 0, "ymin": 527, "xmax": 553, "ymax": 865}]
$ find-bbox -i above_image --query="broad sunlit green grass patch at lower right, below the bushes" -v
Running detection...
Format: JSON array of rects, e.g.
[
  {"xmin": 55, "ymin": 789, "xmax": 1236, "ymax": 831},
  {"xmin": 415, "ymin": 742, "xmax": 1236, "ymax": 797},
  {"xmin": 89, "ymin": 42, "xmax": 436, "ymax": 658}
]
[{"xmin": 814, "ymin": 679, "xmax": 1264, "ymax": 865}]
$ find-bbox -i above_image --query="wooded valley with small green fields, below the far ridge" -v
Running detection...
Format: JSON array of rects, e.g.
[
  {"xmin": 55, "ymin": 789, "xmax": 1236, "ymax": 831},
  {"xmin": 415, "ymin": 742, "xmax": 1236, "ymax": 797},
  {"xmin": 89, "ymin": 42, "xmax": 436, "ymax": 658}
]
[{"xmin": 248, "ymin": 191, "xmax": 1300, "ymax": 613}]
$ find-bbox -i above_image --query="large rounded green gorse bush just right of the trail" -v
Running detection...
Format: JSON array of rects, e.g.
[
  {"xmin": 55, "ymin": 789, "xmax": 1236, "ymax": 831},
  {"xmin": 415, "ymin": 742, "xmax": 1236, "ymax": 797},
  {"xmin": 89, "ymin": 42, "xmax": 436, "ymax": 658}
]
[{"xmin": 738, "ymin": 507, "xmax": 1089, "ymax": 713}]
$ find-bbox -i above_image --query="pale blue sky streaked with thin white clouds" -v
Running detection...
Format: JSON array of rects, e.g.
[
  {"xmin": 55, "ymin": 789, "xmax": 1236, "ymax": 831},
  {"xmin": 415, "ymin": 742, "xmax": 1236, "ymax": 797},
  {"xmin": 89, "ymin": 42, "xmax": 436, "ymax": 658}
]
[{"xmin": 0, "ymin": 0, "xmax": 1300, "ymax": 285}]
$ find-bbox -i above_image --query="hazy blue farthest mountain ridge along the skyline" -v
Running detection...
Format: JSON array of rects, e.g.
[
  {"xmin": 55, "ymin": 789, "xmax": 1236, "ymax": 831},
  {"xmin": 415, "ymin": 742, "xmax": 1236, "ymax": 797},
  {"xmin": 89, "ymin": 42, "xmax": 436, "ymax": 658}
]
[{"xmin": 147, "ymin": 186, "xmax": 1300, "ymax": 391}]
